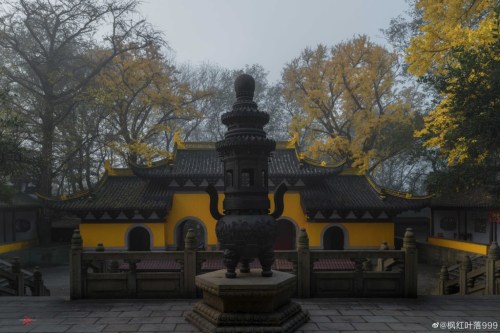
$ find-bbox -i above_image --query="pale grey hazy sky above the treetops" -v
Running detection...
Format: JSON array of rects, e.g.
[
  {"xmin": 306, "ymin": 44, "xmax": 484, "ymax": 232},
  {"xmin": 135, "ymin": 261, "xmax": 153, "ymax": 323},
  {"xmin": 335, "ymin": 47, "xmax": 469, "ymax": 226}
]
[{"xmin": 140, "ymin": 0, "xmax": 408, "ymax": 82}]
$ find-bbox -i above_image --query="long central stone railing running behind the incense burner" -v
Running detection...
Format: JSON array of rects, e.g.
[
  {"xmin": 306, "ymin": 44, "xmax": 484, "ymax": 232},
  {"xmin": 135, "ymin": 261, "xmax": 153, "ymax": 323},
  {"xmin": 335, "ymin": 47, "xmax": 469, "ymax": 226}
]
[{"xmin": 70, "ymin": 229, "xmax": 417, "ymax": 299}]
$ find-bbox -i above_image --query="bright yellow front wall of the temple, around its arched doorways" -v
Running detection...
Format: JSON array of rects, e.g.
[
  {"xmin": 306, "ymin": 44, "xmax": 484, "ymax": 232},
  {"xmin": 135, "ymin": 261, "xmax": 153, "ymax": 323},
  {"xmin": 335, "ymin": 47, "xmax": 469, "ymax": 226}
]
[{"xmin": 80, "ymin": 192, "xmax": 394, "ymax": 250}]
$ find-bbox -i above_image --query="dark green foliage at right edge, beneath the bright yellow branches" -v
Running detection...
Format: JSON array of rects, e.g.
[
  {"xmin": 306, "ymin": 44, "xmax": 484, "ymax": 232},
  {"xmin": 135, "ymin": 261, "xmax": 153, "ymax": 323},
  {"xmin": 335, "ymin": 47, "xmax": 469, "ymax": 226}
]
[{"xmin": 422, "ymin": 28, "xmax": 500, "ymax": 193}]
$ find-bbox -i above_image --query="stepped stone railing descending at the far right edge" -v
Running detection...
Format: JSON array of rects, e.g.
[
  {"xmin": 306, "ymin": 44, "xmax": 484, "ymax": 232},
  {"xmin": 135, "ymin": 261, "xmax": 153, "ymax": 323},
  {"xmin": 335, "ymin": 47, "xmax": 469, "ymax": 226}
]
[{"xmin": 437, "ymin": 241, "xmax": 500, "ymax": 295}]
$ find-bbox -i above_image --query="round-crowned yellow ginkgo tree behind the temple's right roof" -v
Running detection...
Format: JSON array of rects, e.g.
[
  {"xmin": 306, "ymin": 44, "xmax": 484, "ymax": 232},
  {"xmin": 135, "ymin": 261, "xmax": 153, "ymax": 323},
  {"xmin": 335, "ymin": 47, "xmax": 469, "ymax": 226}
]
[{"xmin": 283, "ymin": 36, "xmax": 419, "ymax": 172}]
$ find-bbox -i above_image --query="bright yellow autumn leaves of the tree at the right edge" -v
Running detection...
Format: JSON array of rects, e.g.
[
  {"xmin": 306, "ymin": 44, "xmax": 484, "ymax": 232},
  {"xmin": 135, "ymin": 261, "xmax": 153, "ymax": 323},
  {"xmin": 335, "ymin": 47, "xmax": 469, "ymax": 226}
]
[{"xmin": 406, "ymin": 0, "xmax": 500, "ymax": 166}]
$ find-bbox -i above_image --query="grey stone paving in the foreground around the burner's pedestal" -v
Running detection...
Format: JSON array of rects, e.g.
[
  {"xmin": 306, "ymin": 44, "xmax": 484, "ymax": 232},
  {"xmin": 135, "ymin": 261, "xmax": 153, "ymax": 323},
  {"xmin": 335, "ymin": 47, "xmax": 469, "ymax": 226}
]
[{"xmin": 0, "ymin": 296, "xmax": 500, "ymax": 333}]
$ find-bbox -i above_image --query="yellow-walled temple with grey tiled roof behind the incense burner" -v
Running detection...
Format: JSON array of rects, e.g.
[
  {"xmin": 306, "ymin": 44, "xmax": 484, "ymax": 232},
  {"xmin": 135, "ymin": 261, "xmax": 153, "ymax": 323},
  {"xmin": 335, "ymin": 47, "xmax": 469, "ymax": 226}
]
[{"xmin": 44, "ymin": 137, "xmax": 430, "ymax": 251}]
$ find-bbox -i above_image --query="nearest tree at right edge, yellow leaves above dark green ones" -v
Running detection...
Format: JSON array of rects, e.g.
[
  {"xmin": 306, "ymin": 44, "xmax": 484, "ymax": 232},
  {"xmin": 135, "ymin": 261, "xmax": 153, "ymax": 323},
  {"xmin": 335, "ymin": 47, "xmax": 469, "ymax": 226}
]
[{"xmin": 406, "ymin": 0, "xmax": 500, "ymax": 192}]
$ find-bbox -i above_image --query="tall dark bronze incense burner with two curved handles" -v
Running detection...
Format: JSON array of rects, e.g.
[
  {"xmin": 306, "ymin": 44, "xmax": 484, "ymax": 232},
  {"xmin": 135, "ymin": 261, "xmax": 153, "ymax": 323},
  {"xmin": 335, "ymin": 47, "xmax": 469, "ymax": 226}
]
[{"xmin": 207, "ymin": 74, "xmax": 287, "ymax": 278}]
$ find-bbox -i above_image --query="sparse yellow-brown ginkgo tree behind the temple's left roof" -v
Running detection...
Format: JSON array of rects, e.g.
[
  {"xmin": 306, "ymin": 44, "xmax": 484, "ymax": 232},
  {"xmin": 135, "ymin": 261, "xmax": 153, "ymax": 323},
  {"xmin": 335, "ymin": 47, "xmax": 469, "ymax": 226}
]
[{"xmin": 90, "ymin": 45, "xmax": 204, "ymax": 163}]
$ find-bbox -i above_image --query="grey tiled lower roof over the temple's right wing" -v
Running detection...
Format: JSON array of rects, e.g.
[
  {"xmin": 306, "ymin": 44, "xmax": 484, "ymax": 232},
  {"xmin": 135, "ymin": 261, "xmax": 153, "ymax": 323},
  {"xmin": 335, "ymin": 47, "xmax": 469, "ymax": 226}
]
[{"xmin": 301, "ymin": 175, "xmax": 430, "ymax": 210}]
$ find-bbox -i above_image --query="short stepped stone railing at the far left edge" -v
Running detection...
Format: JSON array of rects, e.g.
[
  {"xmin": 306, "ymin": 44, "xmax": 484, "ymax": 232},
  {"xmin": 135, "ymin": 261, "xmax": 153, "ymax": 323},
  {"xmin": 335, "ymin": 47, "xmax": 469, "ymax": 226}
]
[{"xmin": 0, "ymin": 257, "xmax": 50, "ymax": 296}]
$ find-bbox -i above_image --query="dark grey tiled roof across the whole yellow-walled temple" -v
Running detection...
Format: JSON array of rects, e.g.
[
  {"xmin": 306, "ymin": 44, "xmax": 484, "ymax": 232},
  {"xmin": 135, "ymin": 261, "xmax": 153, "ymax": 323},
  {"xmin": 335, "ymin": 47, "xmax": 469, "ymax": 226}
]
[{"xmin": 46, "ymin": 149, "xmax": 429, "ymax": 212}]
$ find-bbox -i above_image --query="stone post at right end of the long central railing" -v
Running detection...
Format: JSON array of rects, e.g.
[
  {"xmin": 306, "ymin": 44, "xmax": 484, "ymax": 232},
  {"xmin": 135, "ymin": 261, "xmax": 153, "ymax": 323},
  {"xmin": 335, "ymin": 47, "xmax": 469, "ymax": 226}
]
[{"xmin": 403, "ymin": 228, "xmax": 418, "ymax": 297}]
